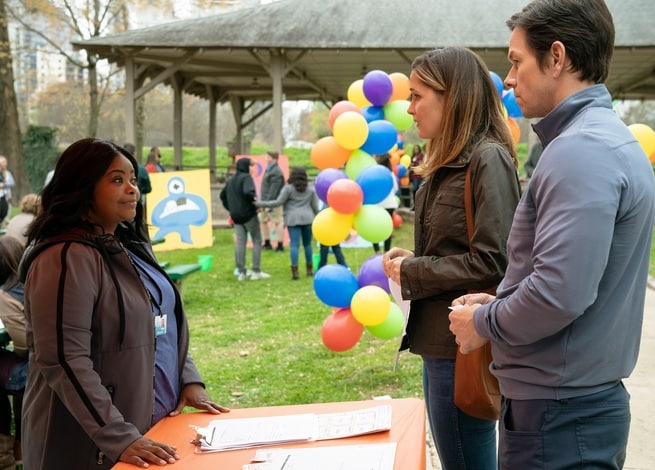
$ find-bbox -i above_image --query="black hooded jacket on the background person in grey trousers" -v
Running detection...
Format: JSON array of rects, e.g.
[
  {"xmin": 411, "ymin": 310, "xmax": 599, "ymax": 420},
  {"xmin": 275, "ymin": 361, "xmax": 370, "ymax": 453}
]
[{"xmin": 221, "ymin": 158, "xmax": 257, "ymax": 224}]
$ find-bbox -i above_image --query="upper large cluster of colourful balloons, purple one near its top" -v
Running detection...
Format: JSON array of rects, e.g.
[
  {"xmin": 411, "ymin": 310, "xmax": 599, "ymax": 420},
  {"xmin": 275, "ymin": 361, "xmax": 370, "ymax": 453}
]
[{"xmin": 310, "ymin": 70, "xmax": 413, "ymax": 246}]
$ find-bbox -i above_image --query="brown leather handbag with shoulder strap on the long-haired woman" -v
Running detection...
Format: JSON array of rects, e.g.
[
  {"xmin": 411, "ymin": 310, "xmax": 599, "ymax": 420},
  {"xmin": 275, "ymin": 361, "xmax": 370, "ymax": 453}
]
[{"xmin": 455, "ymin": 164, "xmax": 500, "ymax": 421}]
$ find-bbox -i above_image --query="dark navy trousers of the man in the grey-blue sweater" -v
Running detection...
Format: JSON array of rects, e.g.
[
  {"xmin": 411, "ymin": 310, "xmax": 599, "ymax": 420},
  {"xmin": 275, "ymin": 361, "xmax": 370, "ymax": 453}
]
[{"xmin": 498, "ymin": 383, "xmax": 630, "ymax": 470}]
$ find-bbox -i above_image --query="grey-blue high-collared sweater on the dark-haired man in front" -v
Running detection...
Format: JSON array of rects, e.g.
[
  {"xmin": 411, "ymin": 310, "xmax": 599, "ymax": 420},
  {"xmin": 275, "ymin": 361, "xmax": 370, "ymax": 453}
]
[{"xmin": 474, "ymin": 85, "xmax": 655, "ymax": 400}]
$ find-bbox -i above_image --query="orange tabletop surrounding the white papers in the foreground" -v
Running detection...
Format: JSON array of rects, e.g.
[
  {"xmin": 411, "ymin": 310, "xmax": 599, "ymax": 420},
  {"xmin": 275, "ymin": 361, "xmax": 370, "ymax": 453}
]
[{"xmin": 114, "ymin": 398, "xmax": 425, "ymax": 470}]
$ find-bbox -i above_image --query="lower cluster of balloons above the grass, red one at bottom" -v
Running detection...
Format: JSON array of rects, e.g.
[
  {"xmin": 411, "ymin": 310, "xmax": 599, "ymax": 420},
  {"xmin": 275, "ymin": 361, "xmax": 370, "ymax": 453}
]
[{"xmin": 314, "ymin": 255, "xmax": 405, "ymax": 352}]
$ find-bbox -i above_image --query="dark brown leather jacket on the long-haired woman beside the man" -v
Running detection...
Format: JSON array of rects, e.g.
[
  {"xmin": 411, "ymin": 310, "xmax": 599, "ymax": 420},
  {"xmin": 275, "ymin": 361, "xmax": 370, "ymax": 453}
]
[{"xmin": 400, "ymin": 142, "xmax": 520, "ymax": 358}]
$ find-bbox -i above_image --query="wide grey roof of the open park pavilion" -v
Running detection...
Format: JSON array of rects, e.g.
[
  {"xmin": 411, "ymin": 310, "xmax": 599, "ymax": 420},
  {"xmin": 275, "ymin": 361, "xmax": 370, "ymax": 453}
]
[{"xmin": 73, "ymin": 0, "xmax": 655, "ymax": 102}]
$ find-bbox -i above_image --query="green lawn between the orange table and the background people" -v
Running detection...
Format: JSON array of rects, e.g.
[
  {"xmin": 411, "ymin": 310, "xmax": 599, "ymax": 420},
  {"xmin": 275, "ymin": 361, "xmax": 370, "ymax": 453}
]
[{"xmin": 158, "ymin": 220, "xmax": 422, "ymax": 408}]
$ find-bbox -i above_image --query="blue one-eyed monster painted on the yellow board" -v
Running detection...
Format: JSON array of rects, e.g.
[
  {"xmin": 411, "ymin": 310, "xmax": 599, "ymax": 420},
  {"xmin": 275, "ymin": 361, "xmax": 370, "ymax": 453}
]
[{"xmin": 152, "ymin": 176, "xmax": 209, "ymax": 245}]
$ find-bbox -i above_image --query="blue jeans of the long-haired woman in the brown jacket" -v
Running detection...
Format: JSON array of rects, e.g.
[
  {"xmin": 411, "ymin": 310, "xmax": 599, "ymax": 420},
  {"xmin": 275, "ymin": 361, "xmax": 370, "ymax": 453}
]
[{"xmin": 423, "ymin": 357, "xmax": 498, "ymax": 470}]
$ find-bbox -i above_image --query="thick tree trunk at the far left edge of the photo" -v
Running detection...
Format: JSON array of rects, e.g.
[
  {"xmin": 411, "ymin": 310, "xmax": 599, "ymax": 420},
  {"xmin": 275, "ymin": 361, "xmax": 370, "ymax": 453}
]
[{"xmin": 0, "ymin": 0, "xmax": 30, "ymax": 196}]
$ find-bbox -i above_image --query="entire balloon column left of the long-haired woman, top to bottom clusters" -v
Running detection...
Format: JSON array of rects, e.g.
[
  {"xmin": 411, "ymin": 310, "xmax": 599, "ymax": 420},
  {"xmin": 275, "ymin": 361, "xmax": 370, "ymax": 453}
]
[{"xmin": 311, "ymin": 70, "xmax": 413, "ymax": 352}]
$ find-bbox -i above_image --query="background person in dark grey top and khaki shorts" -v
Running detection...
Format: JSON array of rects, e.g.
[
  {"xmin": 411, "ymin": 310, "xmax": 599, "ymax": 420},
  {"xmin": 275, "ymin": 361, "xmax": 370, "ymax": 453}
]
[{"xmin": 259, "ymin": 150, "xmax": 284, "ymax": 251}]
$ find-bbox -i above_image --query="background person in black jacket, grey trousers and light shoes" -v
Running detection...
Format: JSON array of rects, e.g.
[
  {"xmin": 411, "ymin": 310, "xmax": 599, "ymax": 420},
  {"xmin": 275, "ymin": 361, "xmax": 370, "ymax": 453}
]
[{"xmin": 220, "ymin": 158, "xmax": 271, "ymax": 281}]
